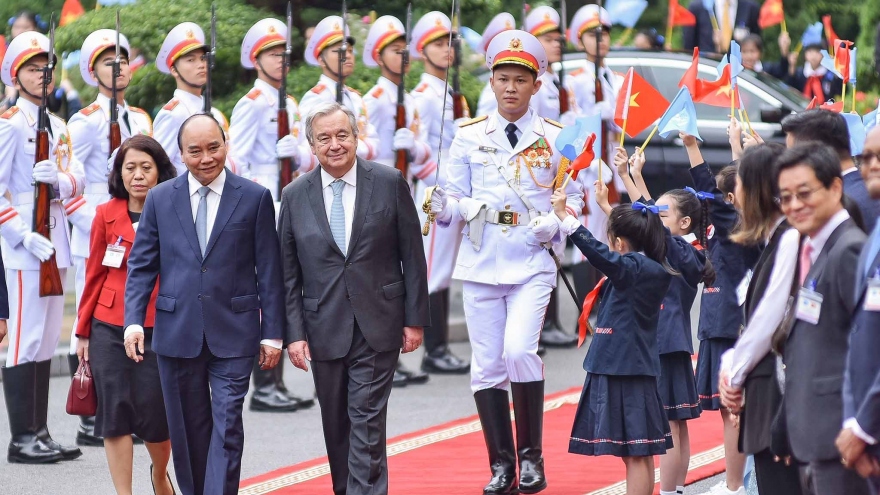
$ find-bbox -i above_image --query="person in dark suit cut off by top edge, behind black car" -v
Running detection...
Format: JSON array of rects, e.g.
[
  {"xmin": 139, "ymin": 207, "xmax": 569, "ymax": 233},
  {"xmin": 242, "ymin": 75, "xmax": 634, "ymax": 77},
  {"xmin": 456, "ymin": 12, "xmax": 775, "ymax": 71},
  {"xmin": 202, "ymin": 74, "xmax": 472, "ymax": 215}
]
[{"xmin": 682, "ymin": 0, "xmax": 761, "ymax": 53}]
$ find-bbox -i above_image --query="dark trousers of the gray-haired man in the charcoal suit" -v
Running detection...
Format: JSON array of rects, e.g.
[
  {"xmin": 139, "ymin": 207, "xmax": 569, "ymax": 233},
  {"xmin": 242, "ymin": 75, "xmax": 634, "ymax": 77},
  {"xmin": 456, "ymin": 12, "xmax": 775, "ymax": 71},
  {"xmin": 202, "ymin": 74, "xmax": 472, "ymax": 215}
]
[{"xmin": 312, "ymin": 324, "xmax": 400, "ymax": 495}]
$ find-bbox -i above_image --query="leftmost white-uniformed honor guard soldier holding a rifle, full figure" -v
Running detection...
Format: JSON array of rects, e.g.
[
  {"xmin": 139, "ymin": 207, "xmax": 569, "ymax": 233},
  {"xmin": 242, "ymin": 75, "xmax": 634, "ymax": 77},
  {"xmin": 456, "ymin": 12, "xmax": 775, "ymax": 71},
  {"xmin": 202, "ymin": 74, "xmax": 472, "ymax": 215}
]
[{"xmin": 0, "ymin": 31, "xmax": 85, "ymax": 464}]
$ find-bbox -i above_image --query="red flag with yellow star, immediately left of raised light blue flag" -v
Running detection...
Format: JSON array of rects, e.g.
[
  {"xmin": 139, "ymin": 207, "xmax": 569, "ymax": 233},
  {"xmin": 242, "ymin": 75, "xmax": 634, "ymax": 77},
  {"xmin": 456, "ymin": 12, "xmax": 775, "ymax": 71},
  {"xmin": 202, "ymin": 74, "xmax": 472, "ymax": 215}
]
[{"xmin": 614, "ymin": 68, "xmax": 669, "ymax": 137}]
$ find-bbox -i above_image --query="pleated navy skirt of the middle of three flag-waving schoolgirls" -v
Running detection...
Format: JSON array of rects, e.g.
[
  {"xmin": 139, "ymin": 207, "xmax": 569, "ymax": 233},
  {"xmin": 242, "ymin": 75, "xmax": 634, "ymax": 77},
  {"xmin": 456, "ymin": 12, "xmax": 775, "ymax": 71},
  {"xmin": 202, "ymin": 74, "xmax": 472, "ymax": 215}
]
[{"xmin": 657, "ymin": 352, "xmax": 700, "ymax": 421}]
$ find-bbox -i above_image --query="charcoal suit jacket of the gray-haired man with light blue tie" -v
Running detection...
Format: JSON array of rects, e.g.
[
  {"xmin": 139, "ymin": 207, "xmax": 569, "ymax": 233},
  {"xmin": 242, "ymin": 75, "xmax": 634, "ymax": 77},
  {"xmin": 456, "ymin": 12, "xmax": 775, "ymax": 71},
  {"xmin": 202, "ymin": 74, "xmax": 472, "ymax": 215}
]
[{"xmin": 279, "ymin": 158, "xmax": 431, "ymax": 360}]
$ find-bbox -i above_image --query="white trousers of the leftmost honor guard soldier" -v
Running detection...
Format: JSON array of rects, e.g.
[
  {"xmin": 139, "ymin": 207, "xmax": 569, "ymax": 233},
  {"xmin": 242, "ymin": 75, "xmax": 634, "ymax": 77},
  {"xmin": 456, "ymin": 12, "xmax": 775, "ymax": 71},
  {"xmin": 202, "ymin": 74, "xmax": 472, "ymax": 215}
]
[{"xmin": 6, "ymin": 268, "xmax": 67, "ymax": 366}]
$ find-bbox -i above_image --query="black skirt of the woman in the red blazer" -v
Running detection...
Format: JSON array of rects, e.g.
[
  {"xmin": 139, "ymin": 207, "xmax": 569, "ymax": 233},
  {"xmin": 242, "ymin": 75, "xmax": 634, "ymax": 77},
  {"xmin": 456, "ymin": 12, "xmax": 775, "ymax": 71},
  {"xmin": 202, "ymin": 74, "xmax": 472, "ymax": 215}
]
[{"xmin": 89, "ymin": 318, "xmax": 169, "ymax": 442}]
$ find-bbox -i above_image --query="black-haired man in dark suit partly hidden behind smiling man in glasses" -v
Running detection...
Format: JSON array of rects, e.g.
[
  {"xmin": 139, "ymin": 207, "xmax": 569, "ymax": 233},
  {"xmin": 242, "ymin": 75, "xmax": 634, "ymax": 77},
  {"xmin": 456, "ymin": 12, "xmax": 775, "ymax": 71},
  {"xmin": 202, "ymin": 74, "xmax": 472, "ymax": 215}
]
[{"xmin": 782, "ymin": 109, "xmax": 880, "ymax": 232}]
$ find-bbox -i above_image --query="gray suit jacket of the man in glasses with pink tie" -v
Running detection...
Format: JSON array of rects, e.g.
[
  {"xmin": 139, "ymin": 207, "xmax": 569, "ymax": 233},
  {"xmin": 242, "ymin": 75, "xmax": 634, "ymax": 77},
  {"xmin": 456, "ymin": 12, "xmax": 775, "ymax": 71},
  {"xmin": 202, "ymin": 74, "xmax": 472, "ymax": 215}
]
[{"xmin": 783, "ymin": 220, "xmax": 865, "ymax": 462}]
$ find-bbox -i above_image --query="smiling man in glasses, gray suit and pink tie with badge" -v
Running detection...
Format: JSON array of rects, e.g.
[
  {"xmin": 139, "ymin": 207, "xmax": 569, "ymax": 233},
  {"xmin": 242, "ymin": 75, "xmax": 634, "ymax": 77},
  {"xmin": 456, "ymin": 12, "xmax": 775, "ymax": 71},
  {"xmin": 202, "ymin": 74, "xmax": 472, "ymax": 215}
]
[{"xmin": 776, "ymin": 142, "xmax": 868, "ymax": 495}]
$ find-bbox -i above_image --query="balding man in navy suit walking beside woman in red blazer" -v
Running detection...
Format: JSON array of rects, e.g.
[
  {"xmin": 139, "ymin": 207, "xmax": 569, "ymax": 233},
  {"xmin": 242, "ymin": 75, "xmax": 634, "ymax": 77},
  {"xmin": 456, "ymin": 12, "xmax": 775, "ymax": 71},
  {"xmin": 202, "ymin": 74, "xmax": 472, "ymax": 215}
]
[{"xmin": 125, "ymin": 114, "xmax": 284, "ymax": 495}]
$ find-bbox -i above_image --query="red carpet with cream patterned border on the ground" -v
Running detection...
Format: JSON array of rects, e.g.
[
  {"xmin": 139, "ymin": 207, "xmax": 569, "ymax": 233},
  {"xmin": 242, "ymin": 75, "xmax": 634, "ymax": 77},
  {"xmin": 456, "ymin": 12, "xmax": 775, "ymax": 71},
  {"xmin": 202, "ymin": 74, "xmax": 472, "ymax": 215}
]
[{"xmin": 239, "ymin": 388, "xmax": 724, "ymax": 495}]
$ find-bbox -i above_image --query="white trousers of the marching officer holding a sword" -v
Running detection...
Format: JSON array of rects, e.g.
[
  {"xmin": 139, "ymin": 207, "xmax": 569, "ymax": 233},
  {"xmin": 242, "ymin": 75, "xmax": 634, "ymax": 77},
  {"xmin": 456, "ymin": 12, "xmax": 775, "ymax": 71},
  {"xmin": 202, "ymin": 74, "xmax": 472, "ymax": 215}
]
[{"xmin": 463, "ymin": 274, "xmax": 555, "ymax": 392}]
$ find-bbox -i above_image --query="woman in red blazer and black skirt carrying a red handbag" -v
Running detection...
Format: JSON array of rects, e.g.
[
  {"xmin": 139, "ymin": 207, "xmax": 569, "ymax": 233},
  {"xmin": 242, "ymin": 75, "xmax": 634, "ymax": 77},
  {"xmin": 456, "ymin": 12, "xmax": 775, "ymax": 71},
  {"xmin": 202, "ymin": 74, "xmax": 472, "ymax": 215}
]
[{"xmin": 76, "ymin": 135, "xmax": 176, "ymax": 495}]
